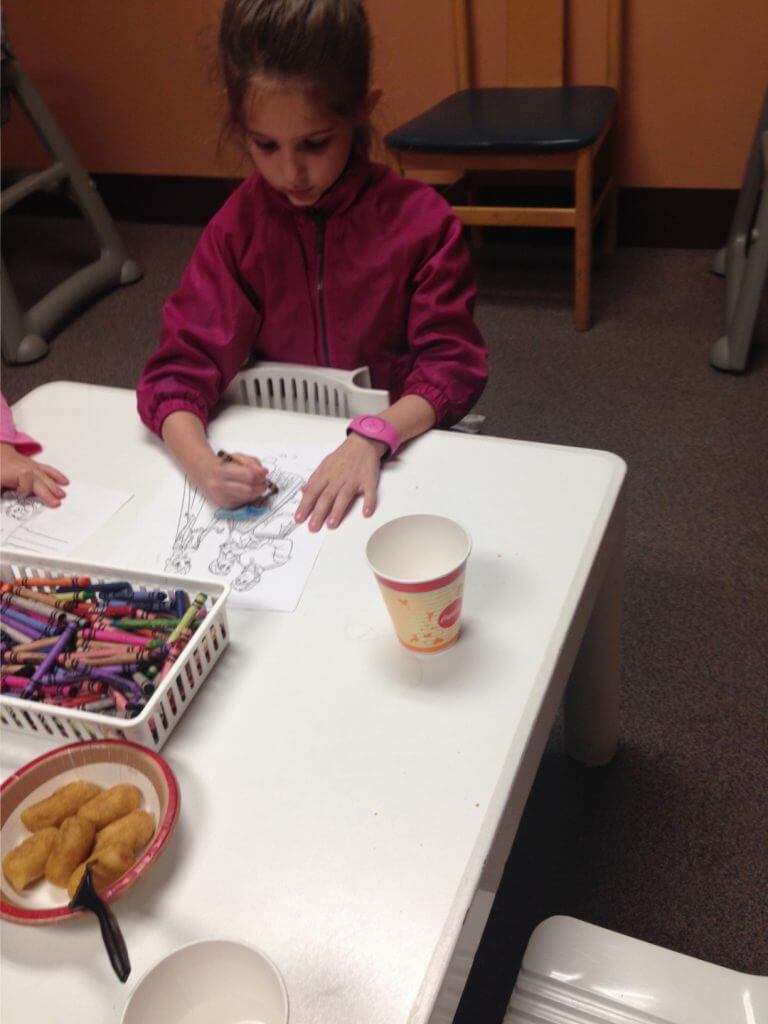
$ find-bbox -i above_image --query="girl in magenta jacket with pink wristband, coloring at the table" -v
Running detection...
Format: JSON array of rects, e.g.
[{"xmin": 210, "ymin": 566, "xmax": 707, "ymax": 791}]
[{"xmin": 138, "ymin": 0, "xmax": 487, "ymax": 530}]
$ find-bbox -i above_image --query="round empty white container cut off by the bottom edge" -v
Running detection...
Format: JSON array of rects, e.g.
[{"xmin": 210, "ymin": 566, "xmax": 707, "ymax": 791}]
[{"xmin": 122, "ymin": 939, "xmax": 288, "ymax": 1024}]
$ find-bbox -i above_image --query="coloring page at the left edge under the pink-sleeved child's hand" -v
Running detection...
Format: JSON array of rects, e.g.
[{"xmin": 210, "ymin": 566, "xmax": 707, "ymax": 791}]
[{"xmin": 0, "ymin": 480, "xmax": 133, "ymax": 555}]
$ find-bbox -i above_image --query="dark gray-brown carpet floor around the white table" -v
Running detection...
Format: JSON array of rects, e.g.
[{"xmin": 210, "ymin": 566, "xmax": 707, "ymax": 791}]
[{"xmin": 2, "ymin": 217, "xmax": 768, "ymax": 1024}]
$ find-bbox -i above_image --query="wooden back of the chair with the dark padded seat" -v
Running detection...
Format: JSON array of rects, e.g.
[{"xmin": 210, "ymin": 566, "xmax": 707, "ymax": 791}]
[{"xmin": 453, "ymin": 0, "xmax": 623, "ymax": 92}]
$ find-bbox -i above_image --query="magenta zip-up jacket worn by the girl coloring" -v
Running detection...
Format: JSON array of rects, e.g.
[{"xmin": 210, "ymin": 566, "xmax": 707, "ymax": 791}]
[{"xmin": 138, "ymin": 158, "xmax": 487, "ymax": 433}]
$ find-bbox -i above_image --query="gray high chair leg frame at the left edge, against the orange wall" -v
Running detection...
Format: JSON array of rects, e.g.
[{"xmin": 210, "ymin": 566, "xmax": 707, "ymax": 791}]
[{"xmin": 0, "ymin": 39, "xmax": 141, "ymax": 362}]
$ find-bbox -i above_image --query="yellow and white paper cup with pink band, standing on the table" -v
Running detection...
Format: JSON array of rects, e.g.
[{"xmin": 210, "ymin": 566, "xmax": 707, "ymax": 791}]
[{"xmin": 366, "ymin": 515, "xmax": 472, "ymax": 654}]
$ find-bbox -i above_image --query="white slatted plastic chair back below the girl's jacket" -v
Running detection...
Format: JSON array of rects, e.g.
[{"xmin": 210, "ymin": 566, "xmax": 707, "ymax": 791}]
[{"xmin": 223, "ymin": 362, "xmax": 389, "ymax": 419}]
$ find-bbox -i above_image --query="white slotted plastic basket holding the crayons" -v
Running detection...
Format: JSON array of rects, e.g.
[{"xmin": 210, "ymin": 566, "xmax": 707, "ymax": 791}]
[{"xmin": 0, "ymin": 551, "xmax": 229, "ymax": 751}]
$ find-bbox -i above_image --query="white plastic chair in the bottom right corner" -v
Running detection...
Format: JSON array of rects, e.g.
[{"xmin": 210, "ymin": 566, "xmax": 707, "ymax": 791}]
[{"xmin": 504, "ymin": 916, "xmax": 768, "ymax": 1024}]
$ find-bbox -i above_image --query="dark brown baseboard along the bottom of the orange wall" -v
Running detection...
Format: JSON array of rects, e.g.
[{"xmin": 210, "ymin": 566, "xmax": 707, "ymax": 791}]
[{"xmin": 3, "ymin": 174, "xmax": 738, "ymax": 249}]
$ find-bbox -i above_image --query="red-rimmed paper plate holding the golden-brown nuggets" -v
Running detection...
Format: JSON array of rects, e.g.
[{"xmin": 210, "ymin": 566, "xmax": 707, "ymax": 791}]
[{"xmin": 0, "ymin": 739, "xmax": 179, "ymax": 925}]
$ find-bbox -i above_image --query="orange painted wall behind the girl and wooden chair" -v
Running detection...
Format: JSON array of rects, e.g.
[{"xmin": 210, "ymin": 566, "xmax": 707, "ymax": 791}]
[{"xmin": 3, "ymin": 0, "xmax": 768, "ymax": 188}]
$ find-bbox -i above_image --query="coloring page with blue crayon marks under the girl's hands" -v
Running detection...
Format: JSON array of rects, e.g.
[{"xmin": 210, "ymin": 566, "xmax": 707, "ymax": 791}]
[{"xmin": 116, "ymin": 440, "xmax": 333, "ymax": 611}]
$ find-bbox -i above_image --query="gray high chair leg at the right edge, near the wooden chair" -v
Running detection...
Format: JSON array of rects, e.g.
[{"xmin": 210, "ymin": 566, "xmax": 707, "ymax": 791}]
[{"xmin": 710, "ymin": 84, "xmax": 768, "ymax": 373}]
